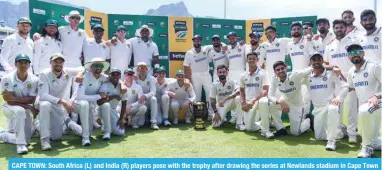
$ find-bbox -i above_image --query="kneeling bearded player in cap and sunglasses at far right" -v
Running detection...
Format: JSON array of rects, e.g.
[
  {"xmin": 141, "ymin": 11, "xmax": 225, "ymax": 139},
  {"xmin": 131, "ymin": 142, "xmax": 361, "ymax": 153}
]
[{"xmin": 347, "ymin": 44, "xmax": 382, "ymax": 158}]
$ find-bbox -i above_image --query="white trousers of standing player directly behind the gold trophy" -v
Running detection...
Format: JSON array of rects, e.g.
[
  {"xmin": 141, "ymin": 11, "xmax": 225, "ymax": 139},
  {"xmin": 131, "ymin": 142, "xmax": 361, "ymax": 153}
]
[{"xmin": 191, "ymin": 72, "xmax": 214, "ymax": 116}]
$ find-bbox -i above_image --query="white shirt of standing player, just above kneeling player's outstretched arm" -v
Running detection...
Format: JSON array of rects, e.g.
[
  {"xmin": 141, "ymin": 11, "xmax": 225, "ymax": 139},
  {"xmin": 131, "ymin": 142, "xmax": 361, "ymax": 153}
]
[{"xmin": 287, "ymin": 37, "xmax": 314, "ymax": 70}]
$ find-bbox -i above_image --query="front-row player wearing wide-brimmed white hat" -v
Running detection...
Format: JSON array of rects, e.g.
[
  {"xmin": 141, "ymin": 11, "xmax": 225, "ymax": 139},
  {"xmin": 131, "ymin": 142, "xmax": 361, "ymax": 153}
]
[{"xmin": 72, "ymin": 58, "xmax": 111, "ymax": 146}]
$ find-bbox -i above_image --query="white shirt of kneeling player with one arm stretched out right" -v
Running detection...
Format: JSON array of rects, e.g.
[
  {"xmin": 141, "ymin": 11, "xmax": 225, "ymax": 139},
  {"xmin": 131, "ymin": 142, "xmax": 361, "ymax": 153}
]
[{"xmin": 268, "ymin": 67, "xmax": 313, "ymax": 106}]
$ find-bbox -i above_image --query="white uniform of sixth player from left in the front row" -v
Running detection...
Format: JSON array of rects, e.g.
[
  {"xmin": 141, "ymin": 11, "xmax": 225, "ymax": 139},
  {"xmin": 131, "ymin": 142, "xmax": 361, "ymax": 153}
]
[{"xmin": 135, "ymin": 74, "xmax": 158, "ymax": 124}]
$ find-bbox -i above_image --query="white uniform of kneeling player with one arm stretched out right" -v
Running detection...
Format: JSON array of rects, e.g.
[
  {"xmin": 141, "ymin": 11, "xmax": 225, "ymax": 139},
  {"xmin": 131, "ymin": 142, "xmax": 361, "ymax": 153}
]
[{"xmin": 268, "ymin": 67, "xmax": 313, "ymax": 136}]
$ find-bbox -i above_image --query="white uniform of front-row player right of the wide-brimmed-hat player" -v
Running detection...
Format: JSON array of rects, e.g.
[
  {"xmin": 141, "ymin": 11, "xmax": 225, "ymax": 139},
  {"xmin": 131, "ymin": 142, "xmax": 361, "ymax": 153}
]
[{"xmin": 99, "ymin": 81, "xmax": 128, "ymax": 136}]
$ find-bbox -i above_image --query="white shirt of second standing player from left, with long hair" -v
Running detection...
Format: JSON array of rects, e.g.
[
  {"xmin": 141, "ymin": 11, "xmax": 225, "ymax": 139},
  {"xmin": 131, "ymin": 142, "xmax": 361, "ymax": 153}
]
[{"xmin": 33, "ymin": 36, "xmax": 62, "ymax": 74}]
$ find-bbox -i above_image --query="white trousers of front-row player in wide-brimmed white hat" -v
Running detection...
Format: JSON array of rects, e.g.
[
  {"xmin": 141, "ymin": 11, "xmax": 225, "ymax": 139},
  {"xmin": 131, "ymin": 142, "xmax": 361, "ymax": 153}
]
[{"xmin": 73, "ymin": 100, "xmax": 111, "ymax": 138}]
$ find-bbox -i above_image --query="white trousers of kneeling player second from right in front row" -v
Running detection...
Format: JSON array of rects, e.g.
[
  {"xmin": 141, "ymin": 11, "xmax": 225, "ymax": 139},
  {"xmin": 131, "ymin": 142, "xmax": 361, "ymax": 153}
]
[{"xmin": 312, "ymin": 103, "xmax": 344, "ymax": 140}]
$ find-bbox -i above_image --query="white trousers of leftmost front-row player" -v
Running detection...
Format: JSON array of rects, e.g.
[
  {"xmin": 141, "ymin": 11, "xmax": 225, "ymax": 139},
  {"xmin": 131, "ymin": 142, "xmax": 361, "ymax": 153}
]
[{"xmin": 2, "ymin": 105, "xmax": 32, "ymax": 145}]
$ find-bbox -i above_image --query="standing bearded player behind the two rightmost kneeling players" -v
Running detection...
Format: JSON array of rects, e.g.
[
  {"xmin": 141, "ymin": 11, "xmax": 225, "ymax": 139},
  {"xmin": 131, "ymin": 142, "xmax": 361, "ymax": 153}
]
[{"xmin": 324, "ymin": 20, "xmax": 358, "ymax": 143}]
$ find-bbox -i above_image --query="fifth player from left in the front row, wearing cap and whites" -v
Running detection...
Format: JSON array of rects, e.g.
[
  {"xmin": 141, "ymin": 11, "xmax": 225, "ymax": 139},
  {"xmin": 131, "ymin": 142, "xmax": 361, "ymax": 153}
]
[{"xmin": 124, "ymin": 68, "xmax": 147, "ymax": 129}]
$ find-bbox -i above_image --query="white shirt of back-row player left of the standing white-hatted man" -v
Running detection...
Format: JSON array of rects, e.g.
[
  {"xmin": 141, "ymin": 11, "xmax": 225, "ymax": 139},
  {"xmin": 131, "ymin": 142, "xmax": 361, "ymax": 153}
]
[{"xmin": 110, "ymin": 39, "xmax": 133, "ymax": 72}]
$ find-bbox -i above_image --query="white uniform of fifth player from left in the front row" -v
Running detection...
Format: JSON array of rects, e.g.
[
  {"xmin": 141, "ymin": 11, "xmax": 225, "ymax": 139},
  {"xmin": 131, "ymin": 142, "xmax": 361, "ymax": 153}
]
[{"xmin": 126, "ymin": 82, "xmax": 147, "ymax": 126}]
